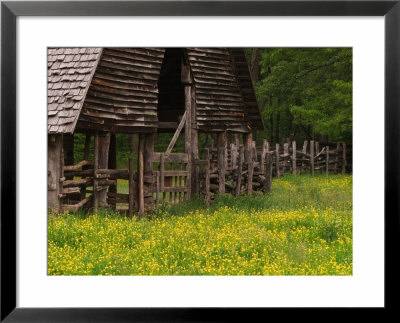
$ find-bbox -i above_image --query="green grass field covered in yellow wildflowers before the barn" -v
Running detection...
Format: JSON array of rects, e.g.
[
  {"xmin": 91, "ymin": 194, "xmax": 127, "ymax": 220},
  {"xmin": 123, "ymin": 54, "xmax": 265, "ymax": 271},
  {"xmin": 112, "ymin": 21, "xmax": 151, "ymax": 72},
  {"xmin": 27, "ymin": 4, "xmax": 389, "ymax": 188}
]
[{"xmin": 48, "ymin": 175, "xmax": 352, "ymax": 275}]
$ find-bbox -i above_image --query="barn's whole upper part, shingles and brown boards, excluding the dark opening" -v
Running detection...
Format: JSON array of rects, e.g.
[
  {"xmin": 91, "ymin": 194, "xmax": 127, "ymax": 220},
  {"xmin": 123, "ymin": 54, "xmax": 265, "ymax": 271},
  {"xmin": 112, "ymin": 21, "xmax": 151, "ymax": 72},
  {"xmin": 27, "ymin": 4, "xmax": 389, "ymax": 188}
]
[{"xmin": 48, "ymin": 48, "xmax": 263, "ymax": 133}]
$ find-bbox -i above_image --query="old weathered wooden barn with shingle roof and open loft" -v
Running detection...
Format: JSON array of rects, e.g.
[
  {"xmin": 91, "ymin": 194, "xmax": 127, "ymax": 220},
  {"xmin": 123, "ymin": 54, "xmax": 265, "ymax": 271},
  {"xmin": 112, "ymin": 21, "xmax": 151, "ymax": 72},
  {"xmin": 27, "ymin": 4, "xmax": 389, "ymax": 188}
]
[{"xmin": 48, "ymin": 47, "xmax": 263, "ymax": 215}]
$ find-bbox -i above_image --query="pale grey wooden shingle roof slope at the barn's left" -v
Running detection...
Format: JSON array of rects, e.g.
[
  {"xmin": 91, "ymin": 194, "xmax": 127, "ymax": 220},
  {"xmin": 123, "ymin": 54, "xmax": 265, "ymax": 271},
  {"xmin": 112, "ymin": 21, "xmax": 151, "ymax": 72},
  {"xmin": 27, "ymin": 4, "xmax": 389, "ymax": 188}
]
[{"xmin": 47, "ymin": 47, "xmax": 102, "ymax": 133}]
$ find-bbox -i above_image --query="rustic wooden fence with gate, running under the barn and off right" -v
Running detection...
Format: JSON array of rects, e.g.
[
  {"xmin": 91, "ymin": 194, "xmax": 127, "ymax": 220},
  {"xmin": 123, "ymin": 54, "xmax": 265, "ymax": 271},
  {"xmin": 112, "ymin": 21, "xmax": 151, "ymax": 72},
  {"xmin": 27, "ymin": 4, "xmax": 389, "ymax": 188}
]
[{"xmin": 60, "ymin": 140, "xmax": 352, "ymax": 216}]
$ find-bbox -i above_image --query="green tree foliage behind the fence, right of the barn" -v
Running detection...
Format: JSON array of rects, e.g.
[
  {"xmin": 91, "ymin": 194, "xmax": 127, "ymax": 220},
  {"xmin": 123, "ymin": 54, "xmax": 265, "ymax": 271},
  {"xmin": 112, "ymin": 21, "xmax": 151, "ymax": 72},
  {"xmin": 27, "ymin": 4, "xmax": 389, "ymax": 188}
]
[{"xmin": 256, "ymin": 48, "xmax": 352, "ymax": 142}]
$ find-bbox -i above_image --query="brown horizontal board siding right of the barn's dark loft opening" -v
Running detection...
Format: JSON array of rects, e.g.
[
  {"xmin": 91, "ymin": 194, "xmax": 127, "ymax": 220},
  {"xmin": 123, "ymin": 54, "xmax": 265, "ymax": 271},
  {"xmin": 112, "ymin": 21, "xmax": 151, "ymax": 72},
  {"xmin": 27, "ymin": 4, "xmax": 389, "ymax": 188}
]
[{"xmin": 187, "ymin": 48, "xmax": 249, "ymax": 132}]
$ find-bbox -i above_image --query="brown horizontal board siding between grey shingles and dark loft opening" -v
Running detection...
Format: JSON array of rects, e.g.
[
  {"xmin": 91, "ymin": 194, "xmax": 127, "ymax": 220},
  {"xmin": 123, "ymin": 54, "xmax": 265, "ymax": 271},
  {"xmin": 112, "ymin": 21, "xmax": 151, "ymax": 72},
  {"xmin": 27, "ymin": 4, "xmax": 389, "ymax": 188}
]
[{"xmin": 77, "ymin": 48, "xmax": 165, "ymax": 133}]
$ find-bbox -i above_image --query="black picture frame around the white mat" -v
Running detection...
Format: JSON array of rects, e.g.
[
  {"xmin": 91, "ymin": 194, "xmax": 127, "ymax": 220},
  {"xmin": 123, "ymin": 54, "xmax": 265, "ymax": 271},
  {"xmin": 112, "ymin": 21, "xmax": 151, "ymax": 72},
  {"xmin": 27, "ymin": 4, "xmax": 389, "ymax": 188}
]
[{"xmin": 0, "ymin": 0, "xmax": 400, "ymax": 322}]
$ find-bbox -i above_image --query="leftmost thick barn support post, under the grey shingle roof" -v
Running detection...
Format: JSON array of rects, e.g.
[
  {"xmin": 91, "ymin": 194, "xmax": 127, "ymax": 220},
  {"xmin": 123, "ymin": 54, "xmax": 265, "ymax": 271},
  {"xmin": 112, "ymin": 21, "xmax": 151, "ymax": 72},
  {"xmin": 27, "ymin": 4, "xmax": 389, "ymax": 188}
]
[{"xmin": 47, "ymin": 135, "xmax": 63, "ymax": 211}]
